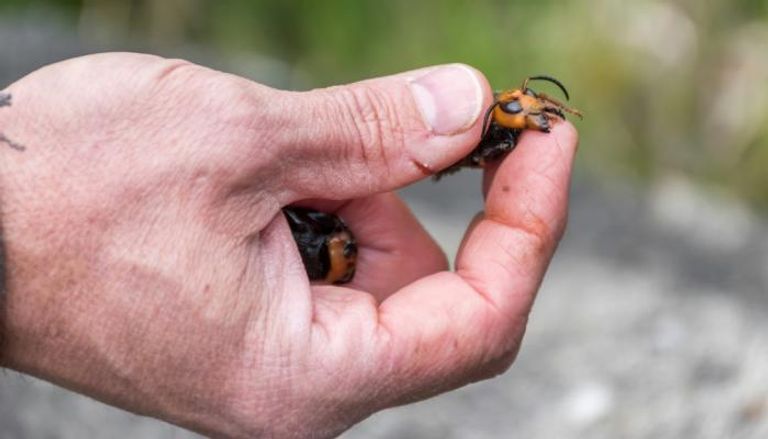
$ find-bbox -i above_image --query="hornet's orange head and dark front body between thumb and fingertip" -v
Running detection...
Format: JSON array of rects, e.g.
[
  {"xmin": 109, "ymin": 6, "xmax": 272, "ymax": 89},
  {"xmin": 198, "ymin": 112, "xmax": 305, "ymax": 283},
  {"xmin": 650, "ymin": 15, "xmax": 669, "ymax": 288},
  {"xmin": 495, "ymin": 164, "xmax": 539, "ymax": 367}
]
[{"xmin": 434, "ymin": 76, "xmax": 581, "ymax": 180}]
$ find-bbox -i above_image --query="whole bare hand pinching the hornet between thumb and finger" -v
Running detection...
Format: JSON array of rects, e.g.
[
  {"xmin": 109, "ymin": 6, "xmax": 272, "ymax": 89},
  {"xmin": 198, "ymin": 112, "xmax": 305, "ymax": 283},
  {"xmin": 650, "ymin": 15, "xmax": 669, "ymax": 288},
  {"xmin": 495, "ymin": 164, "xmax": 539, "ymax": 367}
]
[{"xmin": 0, "ymin": 53, "xmax": 577, "ymax": 438}]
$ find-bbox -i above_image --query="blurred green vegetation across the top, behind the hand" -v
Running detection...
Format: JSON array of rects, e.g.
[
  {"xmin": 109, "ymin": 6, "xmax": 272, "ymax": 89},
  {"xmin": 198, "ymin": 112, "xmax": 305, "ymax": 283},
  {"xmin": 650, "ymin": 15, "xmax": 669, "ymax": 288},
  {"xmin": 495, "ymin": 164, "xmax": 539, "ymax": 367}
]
[{"xmin": 0, "ymin": 0, "xmax": 768, "ymax": 208}]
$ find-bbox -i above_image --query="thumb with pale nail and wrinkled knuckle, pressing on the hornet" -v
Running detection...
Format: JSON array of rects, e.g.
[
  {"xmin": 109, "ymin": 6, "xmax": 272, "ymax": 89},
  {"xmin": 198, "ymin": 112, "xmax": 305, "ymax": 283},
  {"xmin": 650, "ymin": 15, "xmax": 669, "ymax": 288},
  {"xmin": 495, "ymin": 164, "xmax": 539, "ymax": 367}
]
[{"xmin": 270, "ymin": 64, "xmax": 492, "ymax": 199}]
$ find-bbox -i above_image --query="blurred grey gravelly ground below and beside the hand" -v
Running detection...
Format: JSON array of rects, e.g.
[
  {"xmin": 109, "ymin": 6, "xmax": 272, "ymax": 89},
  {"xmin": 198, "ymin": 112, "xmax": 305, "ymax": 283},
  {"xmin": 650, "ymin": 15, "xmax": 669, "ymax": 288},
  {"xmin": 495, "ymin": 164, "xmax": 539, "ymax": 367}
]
[{"xmin": 0, "ymin": 13, "xmax": 768, "ymax": 439}]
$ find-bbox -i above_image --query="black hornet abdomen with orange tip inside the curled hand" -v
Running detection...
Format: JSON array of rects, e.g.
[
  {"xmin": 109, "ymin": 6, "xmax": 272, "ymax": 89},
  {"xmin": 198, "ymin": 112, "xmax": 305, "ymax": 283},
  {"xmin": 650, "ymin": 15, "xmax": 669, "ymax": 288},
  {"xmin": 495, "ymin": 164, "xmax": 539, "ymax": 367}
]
[{"xmin": 283, "ymin": 207, "xmax": 357, "ymax": 283}]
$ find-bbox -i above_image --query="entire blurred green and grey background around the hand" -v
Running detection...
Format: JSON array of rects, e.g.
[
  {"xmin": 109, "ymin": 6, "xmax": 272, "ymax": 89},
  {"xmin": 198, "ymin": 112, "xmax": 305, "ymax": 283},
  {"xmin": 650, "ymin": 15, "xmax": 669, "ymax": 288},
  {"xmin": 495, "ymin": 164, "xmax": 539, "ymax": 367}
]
[{"xmin": 0, "ymin": 0, "xmax": 768, "ymax": 438}]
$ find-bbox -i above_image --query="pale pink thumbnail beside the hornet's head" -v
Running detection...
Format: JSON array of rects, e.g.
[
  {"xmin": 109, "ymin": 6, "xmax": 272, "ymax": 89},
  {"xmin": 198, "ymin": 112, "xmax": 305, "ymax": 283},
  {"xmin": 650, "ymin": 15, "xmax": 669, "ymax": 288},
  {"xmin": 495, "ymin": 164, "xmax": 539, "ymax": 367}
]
[{"xmin": 410, "ymin": 64, "xmax": 483, "ymax": 135}]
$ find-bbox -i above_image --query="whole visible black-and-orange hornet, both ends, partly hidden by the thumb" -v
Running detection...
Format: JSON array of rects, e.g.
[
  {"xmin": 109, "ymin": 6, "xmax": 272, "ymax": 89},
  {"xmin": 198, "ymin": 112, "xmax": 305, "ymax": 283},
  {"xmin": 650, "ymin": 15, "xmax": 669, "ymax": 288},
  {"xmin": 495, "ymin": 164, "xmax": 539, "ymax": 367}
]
[{"xmin": 283, "ymin": 75, "xmax": 582, "ymax": 283}]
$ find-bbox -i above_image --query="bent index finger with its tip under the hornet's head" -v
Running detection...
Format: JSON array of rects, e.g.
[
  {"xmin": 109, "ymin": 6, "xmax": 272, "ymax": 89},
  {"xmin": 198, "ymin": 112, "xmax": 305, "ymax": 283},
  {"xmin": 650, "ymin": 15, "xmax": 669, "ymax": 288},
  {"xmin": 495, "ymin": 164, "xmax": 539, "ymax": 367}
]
[{"xmin": 379, "ymin": 122, "xmax": 577, "ymax": 396}]
